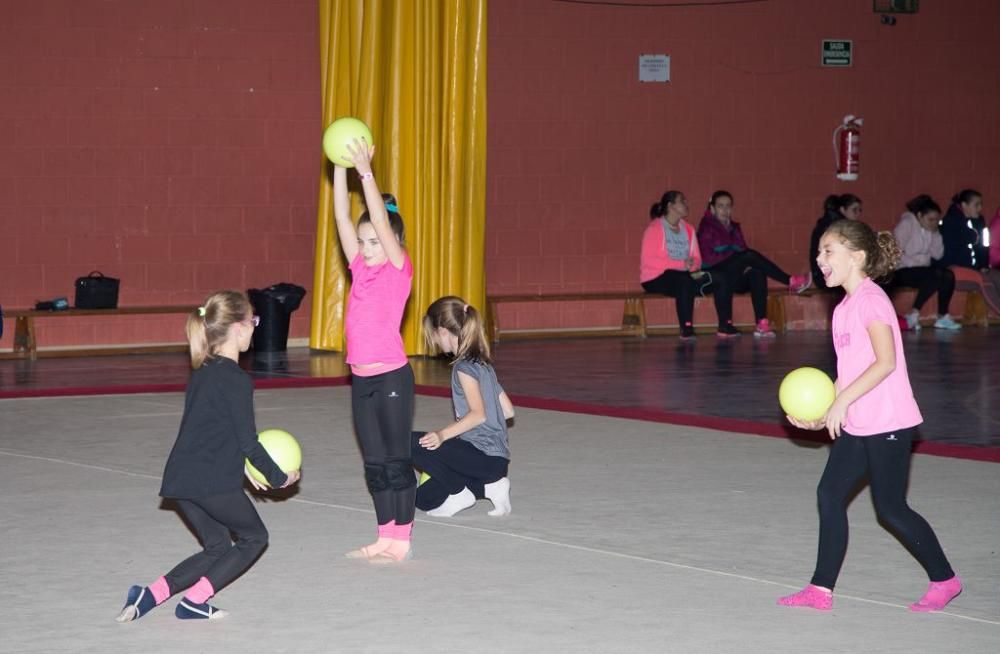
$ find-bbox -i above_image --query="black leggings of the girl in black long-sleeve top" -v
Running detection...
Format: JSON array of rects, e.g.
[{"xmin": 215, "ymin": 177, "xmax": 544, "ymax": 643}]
[{"xmin": 164, "ymin": 491, "xmax": 267, "ymax": 595}]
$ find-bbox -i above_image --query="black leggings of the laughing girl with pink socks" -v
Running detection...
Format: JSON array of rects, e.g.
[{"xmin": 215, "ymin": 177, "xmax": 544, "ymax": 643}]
[{"xmin": 812, "ymin": 428, "xmax": 955, "ymax": 589}]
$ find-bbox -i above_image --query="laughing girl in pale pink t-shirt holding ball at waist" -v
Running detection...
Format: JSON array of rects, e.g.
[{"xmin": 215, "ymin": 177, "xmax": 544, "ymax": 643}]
[{"xmin": 778, "ymin": 220, "xmax": 962, "ymax": 611}]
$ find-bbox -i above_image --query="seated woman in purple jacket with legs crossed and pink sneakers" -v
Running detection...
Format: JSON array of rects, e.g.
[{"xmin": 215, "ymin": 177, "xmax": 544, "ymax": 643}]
[{"xmin": 698, "ymin": 191, "xmax": 812, "ymax": 338}]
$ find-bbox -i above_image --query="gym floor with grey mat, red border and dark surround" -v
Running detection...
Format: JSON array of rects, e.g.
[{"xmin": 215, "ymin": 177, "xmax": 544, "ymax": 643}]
[{"xmin": 0, "ymin": 329, "xmax": 1000, "ymax": 653}]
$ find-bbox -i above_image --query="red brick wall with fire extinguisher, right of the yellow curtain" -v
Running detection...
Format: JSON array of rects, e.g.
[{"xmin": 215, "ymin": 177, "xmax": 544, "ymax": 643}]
[{"xmin": 486, "ymin": 0, "xmax": 1000, "ymax": 328}]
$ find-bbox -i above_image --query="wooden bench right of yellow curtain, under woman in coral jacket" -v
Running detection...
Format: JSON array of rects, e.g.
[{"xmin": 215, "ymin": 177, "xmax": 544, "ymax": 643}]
[{"xmin": 486, "ymin": 289, "xmax": 786, "ymax": 343}]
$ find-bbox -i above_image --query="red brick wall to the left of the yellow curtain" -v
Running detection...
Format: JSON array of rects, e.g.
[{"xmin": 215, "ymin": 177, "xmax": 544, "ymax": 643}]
[{"xmin": 0, "ymin": 0, "xmax": 321, "ymax": 348}]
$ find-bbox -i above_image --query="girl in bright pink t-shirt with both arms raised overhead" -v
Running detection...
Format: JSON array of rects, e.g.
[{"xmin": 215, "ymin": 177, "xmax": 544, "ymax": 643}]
[{"xmin": 333, "ymin": 140, "xmax": 417, "ymax": 563}]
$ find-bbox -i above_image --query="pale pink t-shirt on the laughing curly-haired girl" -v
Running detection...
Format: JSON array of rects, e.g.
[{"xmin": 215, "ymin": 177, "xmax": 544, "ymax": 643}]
[{"xmin": 833, "ymin": 278, "xmax": 924, "ymax": 436}]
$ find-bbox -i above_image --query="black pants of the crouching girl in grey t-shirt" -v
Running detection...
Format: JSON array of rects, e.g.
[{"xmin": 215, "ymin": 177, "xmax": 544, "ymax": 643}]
[{"xmin": 411, "ymin": 431, "xmax": 510, "ymax": 511}]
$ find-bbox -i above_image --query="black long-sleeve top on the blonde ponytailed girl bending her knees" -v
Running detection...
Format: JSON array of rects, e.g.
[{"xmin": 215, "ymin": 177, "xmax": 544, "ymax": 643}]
[{"xmin": 160, "ymin": 357, "xmax": 288, "ymax": 499}]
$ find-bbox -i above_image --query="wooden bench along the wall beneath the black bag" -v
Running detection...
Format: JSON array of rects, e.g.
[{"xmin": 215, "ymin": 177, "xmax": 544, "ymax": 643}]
[{"xmin": 0, "ymin": 305, "xmax": 197, "ymax": 359}]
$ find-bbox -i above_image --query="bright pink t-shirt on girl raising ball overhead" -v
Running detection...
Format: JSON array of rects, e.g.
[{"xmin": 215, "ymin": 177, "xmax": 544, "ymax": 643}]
[{"xmin": 344, "ymin": 252, "xmax": 413, "ymax": 371}]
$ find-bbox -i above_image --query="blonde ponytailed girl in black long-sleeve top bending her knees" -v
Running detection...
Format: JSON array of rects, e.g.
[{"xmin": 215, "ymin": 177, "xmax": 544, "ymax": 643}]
[{"xmin": 117, "ymin": 291, "xmax": 299, "ymax": 622}]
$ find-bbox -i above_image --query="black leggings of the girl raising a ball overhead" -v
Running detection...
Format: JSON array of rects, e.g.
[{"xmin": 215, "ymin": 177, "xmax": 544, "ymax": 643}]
[{"xmin": 351, "ymin": 364, "xmax": 417, "ymax": 525}]
